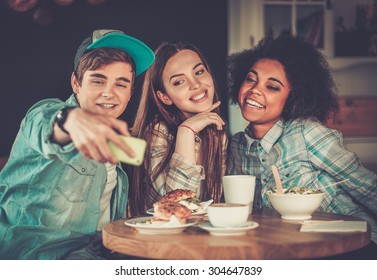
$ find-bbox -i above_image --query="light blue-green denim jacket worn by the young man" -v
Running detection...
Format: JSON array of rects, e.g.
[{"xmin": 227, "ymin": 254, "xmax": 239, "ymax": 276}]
[{"xmin": 0, "ymin": 95, "xmax": 128, "ymax": 259}]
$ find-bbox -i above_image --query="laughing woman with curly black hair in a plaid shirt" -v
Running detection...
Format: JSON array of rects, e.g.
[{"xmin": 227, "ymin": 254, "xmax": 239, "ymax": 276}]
[{"xmin": 227, "ymin": 32, "xmax": 377, "ymax": 249}]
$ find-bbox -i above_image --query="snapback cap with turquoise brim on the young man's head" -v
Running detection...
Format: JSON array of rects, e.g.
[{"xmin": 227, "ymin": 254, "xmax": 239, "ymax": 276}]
[{"xmin": 74, "ymin": 29, "xmax": 155, "ymax": 76}]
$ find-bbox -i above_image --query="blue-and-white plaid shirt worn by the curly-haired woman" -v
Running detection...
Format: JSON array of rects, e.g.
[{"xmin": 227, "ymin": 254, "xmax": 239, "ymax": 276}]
[{"xmin": 227, "ymin": 120, "xmax": 377, "ymax": 243}]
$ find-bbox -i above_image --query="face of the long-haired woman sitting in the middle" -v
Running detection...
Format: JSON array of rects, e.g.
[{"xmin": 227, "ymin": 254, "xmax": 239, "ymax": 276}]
[{"xmin": 157, "ymin": 50, "xmax": 215, "ymax": 117}]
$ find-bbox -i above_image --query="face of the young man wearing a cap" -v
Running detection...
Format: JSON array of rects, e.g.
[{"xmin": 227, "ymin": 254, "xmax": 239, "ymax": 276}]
[{"xmin": 71, "ymin": 62, "xmax": 133, "ymax": 118}]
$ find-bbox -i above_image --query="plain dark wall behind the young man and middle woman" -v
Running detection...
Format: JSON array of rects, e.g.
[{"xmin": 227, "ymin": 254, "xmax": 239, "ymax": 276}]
[{"xmin": 0, "ymin": 0, "xmax": 227, "ymax": 156}]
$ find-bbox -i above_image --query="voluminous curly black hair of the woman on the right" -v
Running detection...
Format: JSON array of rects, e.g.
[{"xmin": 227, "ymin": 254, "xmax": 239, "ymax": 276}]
[{"xmin": 227, "ymin": 34, "xmax": 339, "ymax": 122}]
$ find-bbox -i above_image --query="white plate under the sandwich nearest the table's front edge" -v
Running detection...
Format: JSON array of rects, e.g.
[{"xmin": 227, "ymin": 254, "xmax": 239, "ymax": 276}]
[{"xmin": 125, "ymin": 216, "xmax": 196, "ymax": 234}]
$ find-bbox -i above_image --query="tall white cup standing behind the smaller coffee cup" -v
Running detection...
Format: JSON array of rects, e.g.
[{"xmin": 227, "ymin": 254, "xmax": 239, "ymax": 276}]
[{"xmin": 222, "ymin": 175, "xmax": 255, "ymax": 214}]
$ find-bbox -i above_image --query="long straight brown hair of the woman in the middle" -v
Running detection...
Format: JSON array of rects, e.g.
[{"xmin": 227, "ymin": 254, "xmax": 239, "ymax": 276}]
[{"xmin": 129, "ymin": 41, "xmax": 226, "ymax": 216}]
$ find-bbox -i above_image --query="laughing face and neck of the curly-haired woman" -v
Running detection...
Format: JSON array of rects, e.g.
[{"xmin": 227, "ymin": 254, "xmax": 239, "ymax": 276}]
[{"xmin": 238, "ymin": 59, "xmax": 291, "ymax": 138}]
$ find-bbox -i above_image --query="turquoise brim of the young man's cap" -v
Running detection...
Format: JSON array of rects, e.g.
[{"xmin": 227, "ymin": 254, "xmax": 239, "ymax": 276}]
[{"xmin": 87, "ymin": 33, "xmax": 154, "ymax": 76}]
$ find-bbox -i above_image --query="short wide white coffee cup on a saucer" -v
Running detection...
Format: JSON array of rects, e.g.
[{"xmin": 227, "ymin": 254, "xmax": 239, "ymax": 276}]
[{"xmin": 208, "ymin": 203, "xmax": 249, "ymax": 228}]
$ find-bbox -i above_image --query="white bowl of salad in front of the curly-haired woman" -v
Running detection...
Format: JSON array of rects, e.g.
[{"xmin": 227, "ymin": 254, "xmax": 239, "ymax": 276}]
[{"xmin": 268, "ymin": 193, "xmax": 324, "ymax": 220}]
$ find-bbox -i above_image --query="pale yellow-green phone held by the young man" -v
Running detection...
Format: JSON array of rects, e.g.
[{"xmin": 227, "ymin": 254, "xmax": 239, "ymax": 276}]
[{"xmin": 108, "ymin": 135, "xmax": 147, "ymax": 166}]
